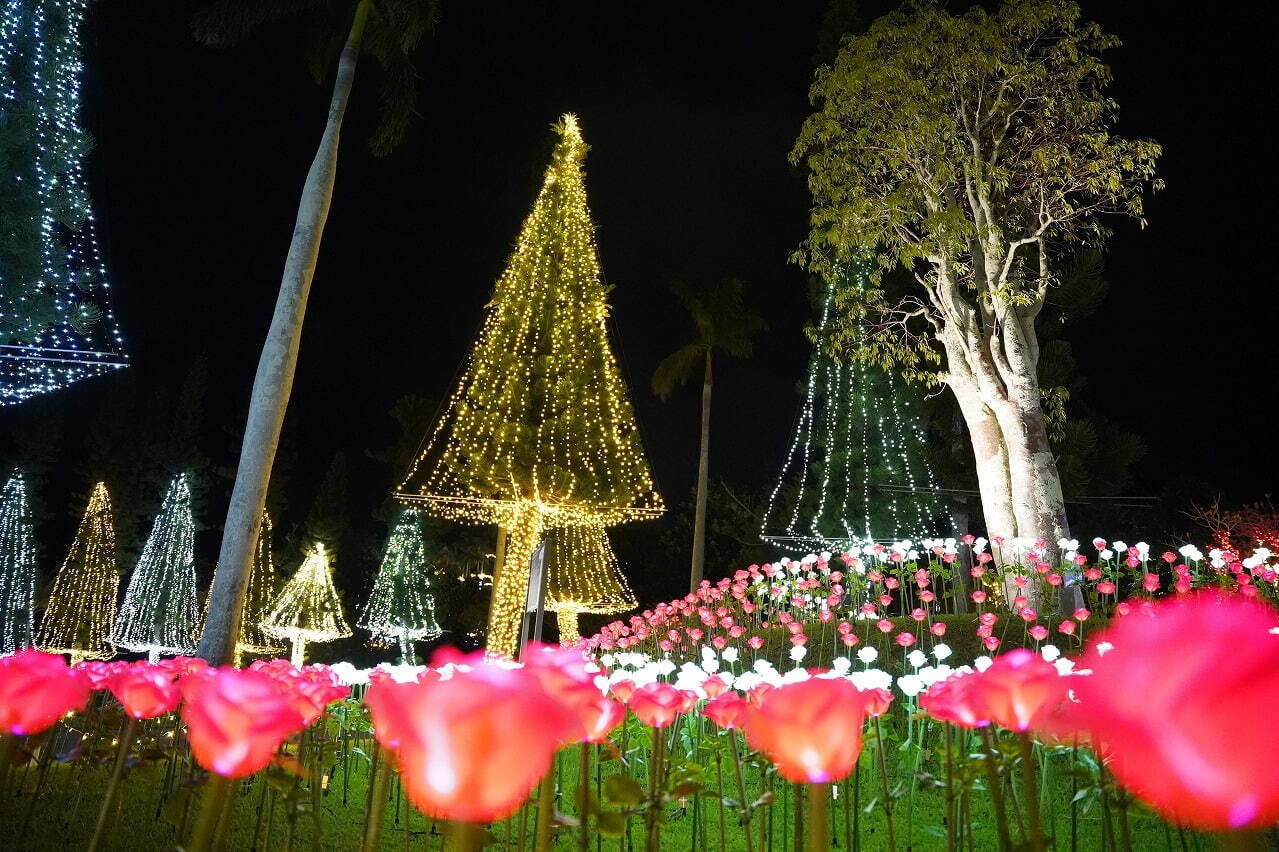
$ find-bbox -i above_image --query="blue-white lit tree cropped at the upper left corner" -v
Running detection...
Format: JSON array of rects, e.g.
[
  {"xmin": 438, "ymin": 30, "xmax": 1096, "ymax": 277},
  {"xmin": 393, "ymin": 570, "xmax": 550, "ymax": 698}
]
[{"xmin": 0, "ymin": 0, "xmax": 127, "ymax": 406}]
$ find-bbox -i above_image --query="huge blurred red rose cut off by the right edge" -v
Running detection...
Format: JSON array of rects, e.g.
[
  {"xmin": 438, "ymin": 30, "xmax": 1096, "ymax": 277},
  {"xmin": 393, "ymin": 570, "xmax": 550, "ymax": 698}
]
[{"xmin": 1074, "ymin": 592, "xmax": 1279, "ymax": 830}]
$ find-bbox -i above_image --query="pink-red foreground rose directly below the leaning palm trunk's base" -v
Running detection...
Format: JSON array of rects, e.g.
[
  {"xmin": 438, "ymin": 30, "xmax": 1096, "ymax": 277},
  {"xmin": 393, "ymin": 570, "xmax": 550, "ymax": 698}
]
[{"xmin": 178, "ymin": 667, "xmax": 306, "ymax": 778}]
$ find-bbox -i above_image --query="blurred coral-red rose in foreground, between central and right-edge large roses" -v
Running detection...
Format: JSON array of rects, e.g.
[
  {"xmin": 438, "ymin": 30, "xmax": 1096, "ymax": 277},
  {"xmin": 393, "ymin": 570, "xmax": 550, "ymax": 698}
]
[{"xmin": 746, "ymin": 678, "xmax": 866, "ymax": 784}]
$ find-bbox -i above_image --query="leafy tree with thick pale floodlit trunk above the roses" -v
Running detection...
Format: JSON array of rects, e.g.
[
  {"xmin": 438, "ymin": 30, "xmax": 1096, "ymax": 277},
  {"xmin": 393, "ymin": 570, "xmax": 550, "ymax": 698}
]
[{"xmin": 792, "ymin": 0, "xmax": 1160, "ymax": 542}]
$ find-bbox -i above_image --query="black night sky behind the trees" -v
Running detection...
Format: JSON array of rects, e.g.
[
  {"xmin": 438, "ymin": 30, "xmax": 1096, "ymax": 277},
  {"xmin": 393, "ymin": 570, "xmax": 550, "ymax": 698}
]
[{"xmin": 2, "ymin": 0, "xmax": 1279, "ymax": 603}]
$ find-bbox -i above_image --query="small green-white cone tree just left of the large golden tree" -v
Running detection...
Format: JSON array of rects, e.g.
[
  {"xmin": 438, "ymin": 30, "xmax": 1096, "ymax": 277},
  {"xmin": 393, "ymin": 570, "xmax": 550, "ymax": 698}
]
[{"xmin": 359, "ymin": 509, "xmax": 441, "ymax": 665}]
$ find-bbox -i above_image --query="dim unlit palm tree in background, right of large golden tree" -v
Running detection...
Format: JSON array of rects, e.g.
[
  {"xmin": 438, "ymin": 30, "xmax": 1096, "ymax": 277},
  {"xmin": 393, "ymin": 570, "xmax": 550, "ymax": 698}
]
[{"xmin": 652, "ymin": 278, "xmax": 767, "ymax": 591}]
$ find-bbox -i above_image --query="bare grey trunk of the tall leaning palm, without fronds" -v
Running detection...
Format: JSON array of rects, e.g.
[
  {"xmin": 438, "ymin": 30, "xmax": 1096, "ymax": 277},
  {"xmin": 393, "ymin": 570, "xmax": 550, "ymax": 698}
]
[{"xmin": 198, "ymin": 0, "xmax": 372, "ymax": 665}]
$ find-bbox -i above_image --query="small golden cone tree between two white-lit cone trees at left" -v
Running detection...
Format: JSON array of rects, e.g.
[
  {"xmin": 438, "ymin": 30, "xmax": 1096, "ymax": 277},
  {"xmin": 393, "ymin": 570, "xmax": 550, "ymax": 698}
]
[{"xmin": 36, "ymin": 482, "xmax": 120, "ymax": 663}]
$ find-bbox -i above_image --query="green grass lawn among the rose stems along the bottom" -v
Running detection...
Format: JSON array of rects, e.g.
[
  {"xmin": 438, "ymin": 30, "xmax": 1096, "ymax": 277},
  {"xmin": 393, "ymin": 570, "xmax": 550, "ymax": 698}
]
[{"xmin": 0, "ymin": 695, "xmax": 1212, "ymax": 852}]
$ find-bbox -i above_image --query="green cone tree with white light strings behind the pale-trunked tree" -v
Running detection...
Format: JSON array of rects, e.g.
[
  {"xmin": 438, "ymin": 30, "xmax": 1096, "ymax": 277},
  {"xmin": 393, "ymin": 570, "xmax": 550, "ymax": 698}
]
[{"xmin": 761, "ymin": 257, "xmax": 954, "ymax": 551}]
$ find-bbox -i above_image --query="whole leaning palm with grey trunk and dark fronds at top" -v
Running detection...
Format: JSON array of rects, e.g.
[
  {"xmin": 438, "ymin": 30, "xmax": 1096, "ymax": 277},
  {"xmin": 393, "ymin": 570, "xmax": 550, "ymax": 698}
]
[{"xmin": 194, "ymin": 0, "xmax": 439, "ymax": 664}]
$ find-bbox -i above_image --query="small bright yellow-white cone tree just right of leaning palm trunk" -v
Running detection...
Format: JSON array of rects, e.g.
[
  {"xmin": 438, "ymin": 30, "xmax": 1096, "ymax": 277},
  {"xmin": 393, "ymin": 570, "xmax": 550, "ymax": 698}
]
[{"xmin": 261, "ymin": 544, "xmax": 350, "ymax": 665}]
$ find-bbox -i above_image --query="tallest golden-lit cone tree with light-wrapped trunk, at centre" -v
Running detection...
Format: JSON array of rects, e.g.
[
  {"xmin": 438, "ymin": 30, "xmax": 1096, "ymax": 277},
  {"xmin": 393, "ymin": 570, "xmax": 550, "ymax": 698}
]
[{"xmin": 398, "ymin": 115, "xmax": 663, "ymax": 654}]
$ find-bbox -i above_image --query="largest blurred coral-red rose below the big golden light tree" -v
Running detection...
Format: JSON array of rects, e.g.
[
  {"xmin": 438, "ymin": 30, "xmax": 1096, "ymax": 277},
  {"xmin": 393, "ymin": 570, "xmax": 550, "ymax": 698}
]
[{"xmin": 365, "ymin": 663, "xmax": 581, "ymax": 823}]
